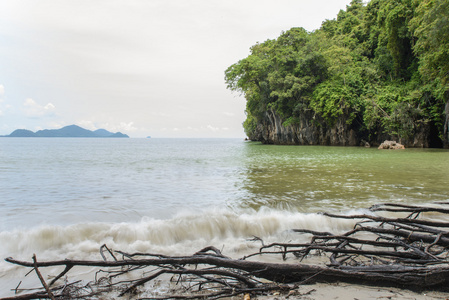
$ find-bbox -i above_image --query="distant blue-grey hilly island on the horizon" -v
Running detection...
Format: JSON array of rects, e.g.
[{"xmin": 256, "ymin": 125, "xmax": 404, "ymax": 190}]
[{"xmin": 2, "ymin": 125, "xmax": 129, "ymax": 138}]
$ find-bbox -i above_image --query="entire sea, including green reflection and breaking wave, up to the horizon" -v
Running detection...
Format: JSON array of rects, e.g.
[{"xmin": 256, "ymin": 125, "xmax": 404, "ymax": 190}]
[{"xmin": 0, "ymin": 138, "xmax": 449, "ymax": 296}]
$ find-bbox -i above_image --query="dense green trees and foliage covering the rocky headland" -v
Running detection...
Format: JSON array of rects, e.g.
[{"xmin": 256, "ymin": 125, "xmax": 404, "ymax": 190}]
[{"xmin": 225, "ymin": 0, "xmax": 449, "ymax": 146}]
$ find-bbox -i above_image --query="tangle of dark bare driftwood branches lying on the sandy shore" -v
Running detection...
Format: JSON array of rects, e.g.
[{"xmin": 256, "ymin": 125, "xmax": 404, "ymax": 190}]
[{"xmin": 3, "ymin": 203, "xmax": 449, "ymax": 300}]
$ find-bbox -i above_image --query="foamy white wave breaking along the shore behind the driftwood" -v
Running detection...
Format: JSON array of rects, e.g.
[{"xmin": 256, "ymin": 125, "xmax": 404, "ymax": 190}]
[{"xmin": 0, "ymin": 209, "xmax": 360, "ymax": 273}]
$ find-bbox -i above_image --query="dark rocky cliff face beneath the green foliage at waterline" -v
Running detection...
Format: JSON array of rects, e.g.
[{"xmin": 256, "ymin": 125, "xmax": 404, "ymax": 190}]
[{"xmin": 249, "ymin": 109, "xmax": 440, "ymax": 148}]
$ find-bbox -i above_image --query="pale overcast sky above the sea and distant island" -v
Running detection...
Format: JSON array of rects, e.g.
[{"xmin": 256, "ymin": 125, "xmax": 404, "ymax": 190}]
[{"xmin": 0, "ymin": 0, "xmax": 350, "ymax": 138}]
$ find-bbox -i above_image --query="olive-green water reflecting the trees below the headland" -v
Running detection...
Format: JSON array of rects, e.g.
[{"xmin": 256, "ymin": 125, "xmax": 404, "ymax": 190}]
[{"xmin": 238, "ymin": 144, "xmax": 449, "ymax": 212}]
